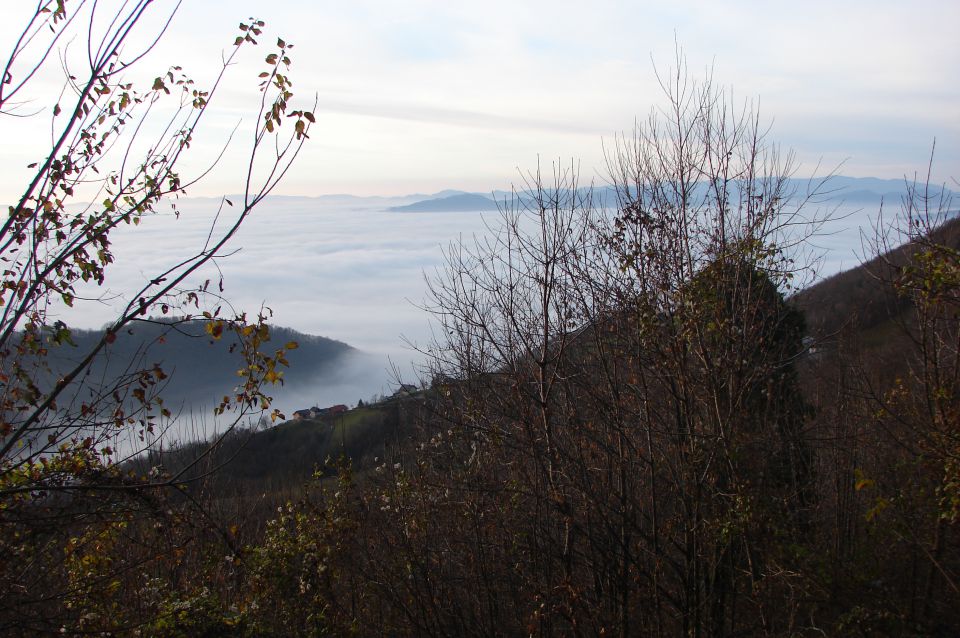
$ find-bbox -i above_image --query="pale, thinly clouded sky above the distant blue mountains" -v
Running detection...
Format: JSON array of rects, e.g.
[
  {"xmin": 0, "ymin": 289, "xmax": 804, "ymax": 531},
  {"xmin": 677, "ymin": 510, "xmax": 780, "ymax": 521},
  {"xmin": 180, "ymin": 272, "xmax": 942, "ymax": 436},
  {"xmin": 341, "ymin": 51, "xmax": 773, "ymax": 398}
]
[{"xmin": 0, "ymin": 0, "xmax": 960, "ymax": 197}]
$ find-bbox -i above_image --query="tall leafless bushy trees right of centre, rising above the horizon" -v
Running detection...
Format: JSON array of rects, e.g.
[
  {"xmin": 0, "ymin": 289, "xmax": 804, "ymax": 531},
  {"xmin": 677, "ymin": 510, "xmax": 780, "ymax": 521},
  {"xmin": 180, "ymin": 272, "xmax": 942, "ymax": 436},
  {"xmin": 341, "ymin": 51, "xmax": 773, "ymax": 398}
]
[{"xmin": 402, "ymin": 56, "xmax": 822, "ymax": 636}]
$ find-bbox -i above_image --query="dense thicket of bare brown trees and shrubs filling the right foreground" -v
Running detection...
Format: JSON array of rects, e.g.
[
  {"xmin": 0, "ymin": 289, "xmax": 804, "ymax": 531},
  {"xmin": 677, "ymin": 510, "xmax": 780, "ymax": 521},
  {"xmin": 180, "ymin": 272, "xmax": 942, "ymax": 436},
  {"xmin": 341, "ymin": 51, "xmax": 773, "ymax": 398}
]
[{"xmin": 214, "ymin": 76, "xmax": 960, "ymax": 636}]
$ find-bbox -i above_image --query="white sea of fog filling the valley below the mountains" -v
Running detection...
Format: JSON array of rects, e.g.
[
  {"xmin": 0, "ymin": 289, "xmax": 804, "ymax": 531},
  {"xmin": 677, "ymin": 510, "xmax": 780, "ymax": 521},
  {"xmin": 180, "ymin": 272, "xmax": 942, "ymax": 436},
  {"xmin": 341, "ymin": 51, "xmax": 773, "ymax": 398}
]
[{"xmin": 68, "ymin": 191, "xmax": 900, "ymax": 420}]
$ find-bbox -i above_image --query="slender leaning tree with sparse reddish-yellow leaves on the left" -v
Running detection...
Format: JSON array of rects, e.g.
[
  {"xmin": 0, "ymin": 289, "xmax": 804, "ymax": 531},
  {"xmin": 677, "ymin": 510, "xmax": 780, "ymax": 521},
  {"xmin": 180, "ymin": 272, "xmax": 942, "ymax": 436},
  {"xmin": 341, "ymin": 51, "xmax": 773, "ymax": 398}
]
[{"xmin": 0, "ymin": 0, "xmax": 314, "ymax": 630}]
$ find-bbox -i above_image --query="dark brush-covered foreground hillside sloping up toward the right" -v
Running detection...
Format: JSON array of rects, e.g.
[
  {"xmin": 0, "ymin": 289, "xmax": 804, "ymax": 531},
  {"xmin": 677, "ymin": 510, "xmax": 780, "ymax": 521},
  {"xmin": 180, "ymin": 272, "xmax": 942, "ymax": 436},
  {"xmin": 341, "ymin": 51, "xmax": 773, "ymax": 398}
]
[{"xmin": 33, "ymin": 207, "xmax": 948, "ymax": 636}]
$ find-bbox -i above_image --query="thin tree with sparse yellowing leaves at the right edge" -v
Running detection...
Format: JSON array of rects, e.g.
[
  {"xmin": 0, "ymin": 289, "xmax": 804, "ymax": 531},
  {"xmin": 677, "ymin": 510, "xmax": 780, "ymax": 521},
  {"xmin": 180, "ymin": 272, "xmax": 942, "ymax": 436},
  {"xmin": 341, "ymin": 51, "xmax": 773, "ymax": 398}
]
[{"xmin": 843, "ymin": 165, "xmax": 960, "ymax": 628}]
